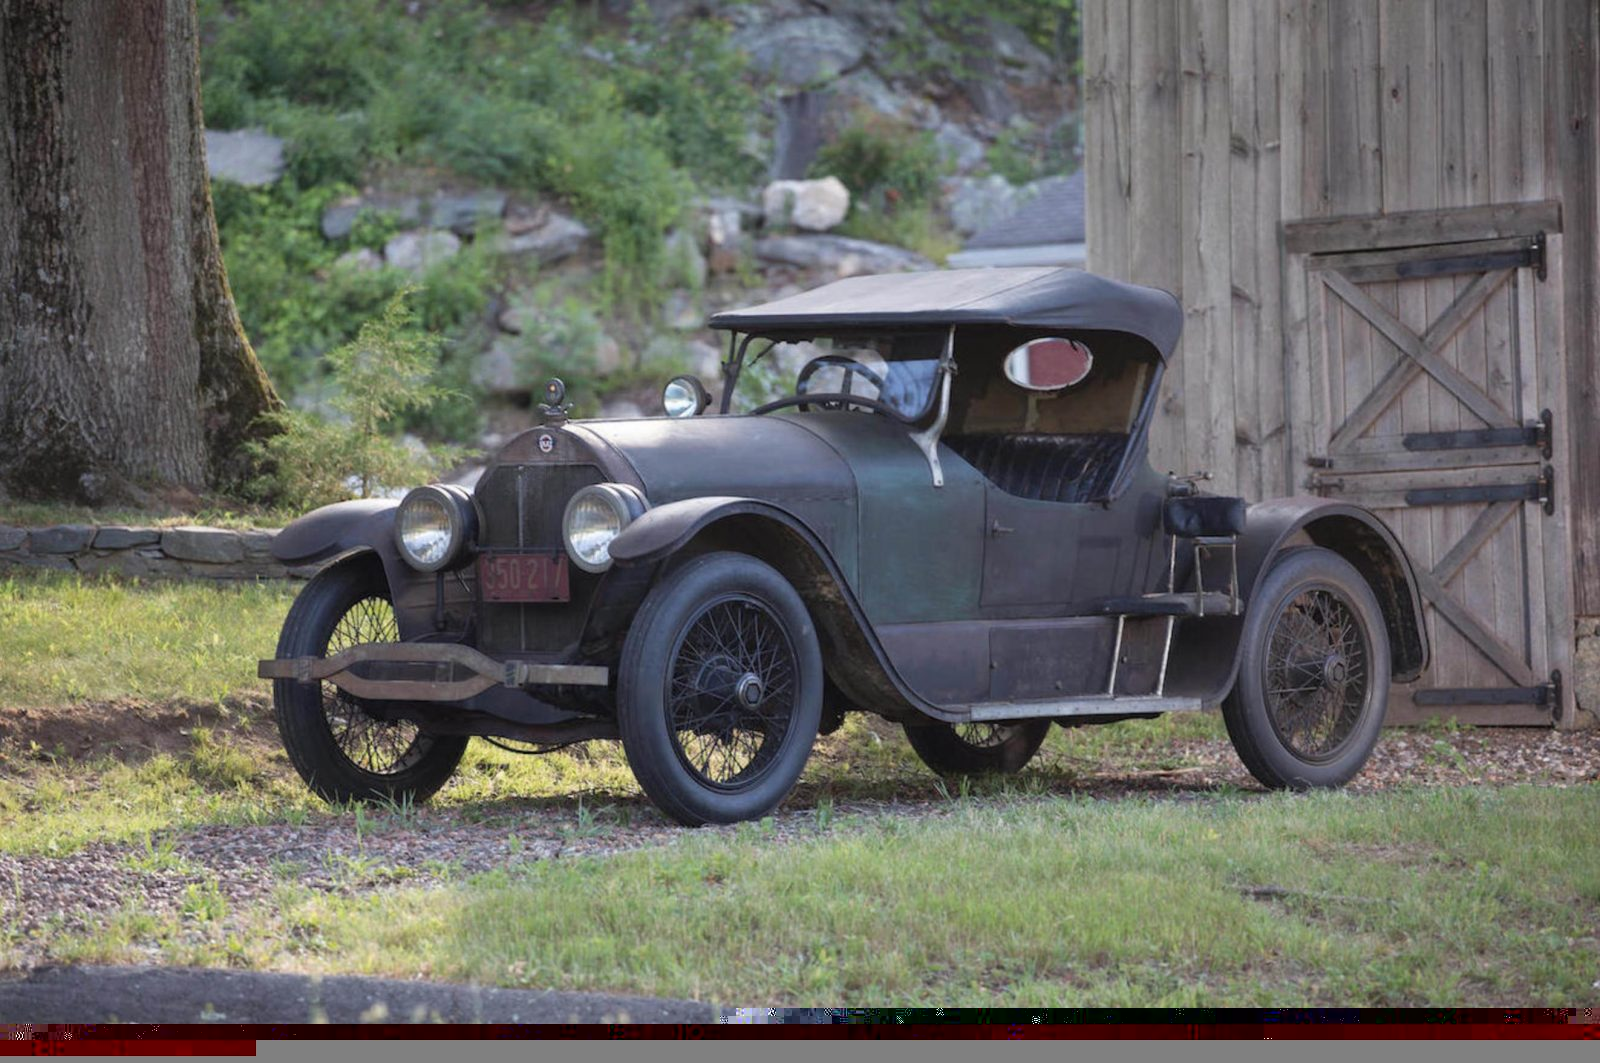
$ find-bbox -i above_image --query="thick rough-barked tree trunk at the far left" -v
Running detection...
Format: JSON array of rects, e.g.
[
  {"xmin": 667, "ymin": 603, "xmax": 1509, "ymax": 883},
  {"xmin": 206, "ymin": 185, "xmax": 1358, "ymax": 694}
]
[{"xmin": 0, "ymin": 0, "xmax": 280, "ymax": 501}]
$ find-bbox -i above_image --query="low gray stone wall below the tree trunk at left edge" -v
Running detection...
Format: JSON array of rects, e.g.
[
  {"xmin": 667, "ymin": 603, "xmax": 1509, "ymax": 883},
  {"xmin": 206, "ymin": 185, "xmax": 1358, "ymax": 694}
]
[{"xmin": 0, "ymin": 523, "xmax": 318, "ymax": 580}]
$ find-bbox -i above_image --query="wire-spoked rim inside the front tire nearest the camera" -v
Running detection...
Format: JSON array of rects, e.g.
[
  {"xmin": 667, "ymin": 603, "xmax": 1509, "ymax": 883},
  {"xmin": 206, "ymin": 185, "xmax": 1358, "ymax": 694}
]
[{"xmin": 666, "ymin": 594, "xmax": 797, "ymax": 791}]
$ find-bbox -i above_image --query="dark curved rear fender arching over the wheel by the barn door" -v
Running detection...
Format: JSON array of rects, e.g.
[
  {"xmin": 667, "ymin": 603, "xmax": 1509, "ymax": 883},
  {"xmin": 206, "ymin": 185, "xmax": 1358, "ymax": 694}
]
[{"xmin": 1168, "ymin": 496, "xmax": 1429, "ymax": 703}]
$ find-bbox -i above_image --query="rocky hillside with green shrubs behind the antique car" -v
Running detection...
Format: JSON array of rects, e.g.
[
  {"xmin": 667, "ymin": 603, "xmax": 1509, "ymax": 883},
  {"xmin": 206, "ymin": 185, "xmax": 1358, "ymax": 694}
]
[{"xmin": 202, "ymin": 0, "xmax": 1078, "ymax": 486}]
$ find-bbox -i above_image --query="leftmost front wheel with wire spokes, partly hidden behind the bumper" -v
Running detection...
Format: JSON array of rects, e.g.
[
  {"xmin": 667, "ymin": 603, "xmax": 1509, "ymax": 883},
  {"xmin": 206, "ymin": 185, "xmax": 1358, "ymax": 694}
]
[{"xmin": 272, "ymin": 562, "xmax": 467, "ymax": 804}]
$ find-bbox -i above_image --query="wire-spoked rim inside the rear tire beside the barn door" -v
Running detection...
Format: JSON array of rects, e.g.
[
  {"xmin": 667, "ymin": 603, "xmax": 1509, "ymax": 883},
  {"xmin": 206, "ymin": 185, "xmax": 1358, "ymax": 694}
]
[{"xmin": 1262, "ymin": 588, "xmax": 1371, "ymax": 764}]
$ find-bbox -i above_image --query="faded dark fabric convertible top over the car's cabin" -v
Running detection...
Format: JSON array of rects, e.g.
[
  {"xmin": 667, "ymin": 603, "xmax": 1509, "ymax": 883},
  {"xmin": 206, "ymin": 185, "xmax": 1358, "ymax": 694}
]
[{"xmin": 710, "ymin": 266, "xmax": 1184, "ymax": 359}]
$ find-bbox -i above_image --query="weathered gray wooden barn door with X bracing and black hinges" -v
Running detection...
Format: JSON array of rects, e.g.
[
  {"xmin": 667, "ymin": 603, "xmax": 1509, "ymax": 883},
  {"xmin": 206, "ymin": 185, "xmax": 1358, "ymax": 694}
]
[{"xmin": 1299, "ymin": 234, "xmax": 1571, "ymax": 724}]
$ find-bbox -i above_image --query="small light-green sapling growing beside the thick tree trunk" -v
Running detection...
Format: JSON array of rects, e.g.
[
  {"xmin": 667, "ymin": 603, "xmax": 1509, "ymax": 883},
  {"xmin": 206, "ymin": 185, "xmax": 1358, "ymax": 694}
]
[{"xmin": 250, "ymin": 291, "xmax": 459, "ymax": 507}]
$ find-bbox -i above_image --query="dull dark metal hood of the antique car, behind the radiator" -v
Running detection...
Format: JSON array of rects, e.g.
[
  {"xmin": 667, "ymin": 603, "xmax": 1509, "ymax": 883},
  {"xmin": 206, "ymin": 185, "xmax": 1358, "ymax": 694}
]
[{"xmin": 568, "ymin": 413, "xmax": 883, "ymax": 506}]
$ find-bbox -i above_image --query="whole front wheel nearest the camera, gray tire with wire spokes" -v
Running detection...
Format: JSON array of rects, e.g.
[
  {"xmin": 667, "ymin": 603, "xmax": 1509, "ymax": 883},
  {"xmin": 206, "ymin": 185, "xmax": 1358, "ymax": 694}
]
[{"xmin": 618, "ymin": 552, "xmax": 822, "ymax": 826}]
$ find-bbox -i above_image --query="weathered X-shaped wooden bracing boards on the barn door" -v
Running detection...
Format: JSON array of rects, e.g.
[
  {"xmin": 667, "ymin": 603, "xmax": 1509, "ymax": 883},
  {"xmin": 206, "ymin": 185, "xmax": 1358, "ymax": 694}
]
[{"xmin": 1309, "ymin": 234, "xmax": 1562, "ymax": 709}]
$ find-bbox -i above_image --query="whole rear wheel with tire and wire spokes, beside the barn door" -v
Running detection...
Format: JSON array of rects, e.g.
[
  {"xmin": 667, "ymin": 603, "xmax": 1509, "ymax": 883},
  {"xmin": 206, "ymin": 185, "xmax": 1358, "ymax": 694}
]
[{"xmin": 1222, "ymin": 548, "xmax": 1389, "ymax": 789}]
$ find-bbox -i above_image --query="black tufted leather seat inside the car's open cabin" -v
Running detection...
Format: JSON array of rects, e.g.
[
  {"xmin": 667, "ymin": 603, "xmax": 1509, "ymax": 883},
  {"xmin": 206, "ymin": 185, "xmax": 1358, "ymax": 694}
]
[{"xmin": 944, "ymin": 432, "xmax": 1128, "ymax": 503}]
